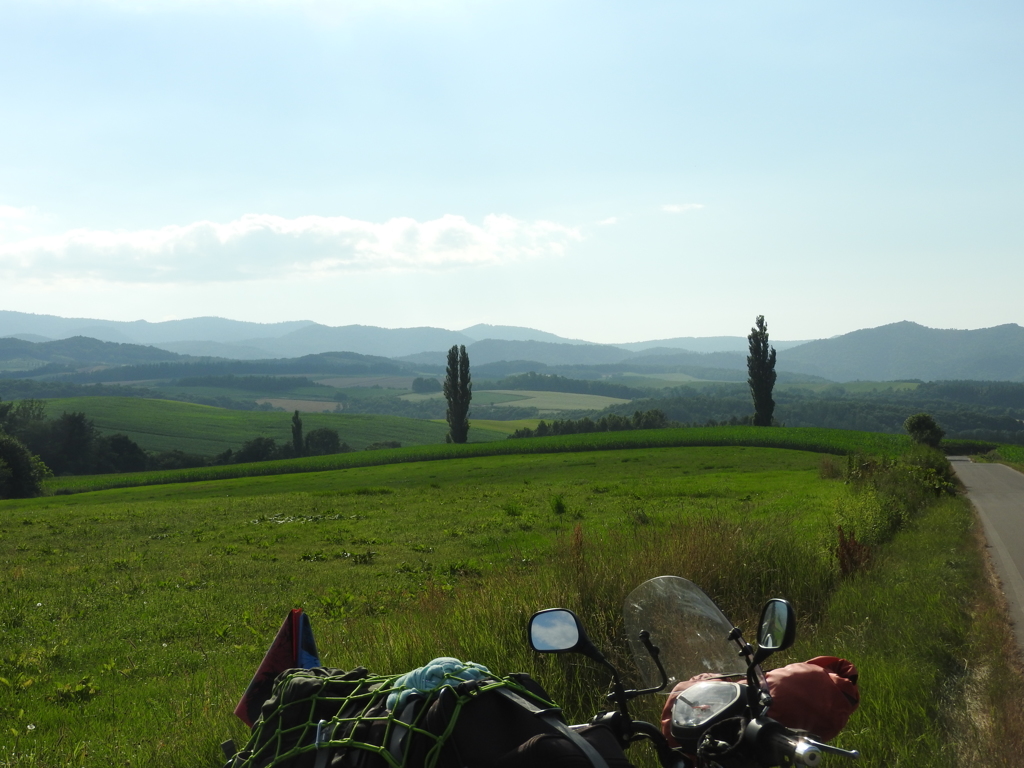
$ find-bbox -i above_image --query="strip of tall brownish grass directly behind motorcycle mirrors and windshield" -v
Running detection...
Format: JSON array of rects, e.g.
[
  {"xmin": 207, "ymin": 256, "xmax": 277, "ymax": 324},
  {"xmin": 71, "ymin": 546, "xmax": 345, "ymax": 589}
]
[{"xmin": 245, "ymin": 516, "xmax": 838, "ymax": 768}]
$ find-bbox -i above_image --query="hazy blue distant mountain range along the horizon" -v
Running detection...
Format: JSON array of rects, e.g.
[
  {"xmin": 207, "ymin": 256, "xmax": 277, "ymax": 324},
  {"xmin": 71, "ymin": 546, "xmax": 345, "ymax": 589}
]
[{"xmin": 0, "ymin": 311, "xmax": 1024, "ymax": 382}]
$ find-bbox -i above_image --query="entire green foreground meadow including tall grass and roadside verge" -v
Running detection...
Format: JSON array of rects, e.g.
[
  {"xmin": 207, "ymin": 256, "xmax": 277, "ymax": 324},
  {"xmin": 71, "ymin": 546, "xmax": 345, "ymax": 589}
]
[{"xmin": 0, "ymin": 430, "xmax": 1021, "ymax": 768}]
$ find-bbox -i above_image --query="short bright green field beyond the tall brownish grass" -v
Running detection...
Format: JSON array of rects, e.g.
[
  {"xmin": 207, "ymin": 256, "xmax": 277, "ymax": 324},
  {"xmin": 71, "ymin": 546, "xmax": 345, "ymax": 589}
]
[{"xmin": 0, "ymin": 447, "xmax": 831, "ymax": 768}]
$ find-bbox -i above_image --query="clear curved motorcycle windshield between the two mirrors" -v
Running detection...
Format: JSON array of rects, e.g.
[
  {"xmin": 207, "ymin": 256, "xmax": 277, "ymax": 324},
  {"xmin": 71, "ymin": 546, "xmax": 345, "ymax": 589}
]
[{"xmin": 623, "ymin": 577, "xmax": 746, "ymax": 690}]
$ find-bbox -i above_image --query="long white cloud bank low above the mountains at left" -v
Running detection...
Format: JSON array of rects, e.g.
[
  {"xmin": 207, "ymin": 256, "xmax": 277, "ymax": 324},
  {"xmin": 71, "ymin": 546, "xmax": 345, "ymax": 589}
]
[{"xmin": 0, "ymin": 214, "xmax": 582, "ymax": 284}]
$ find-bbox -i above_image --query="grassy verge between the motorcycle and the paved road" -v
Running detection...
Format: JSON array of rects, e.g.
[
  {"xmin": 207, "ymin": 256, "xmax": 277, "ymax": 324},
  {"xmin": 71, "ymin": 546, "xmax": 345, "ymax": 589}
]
[{"xmin": 805, "ymin": 499, "xmax": 1024, "ymax": 767}]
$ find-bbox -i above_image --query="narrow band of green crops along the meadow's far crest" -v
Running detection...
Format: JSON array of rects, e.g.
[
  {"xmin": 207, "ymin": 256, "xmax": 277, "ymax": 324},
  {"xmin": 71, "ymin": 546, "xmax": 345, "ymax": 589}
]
[{"xmin": 39, "ymin": 422, "xmax": 910, "ymax": 494}]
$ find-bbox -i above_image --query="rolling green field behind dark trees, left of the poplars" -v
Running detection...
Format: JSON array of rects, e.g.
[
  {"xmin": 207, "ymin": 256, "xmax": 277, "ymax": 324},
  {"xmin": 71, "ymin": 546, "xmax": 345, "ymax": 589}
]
[{"xmin": 34, "ymin": 397, "xmax": 504, "ymax": 456}]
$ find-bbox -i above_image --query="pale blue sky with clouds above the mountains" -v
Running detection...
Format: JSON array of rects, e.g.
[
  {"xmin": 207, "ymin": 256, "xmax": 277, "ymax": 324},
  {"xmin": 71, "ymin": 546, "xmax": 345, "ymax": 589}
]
[{"xmin": 0, "ymin": 0, "xmax": 1024, "ymax": 343}]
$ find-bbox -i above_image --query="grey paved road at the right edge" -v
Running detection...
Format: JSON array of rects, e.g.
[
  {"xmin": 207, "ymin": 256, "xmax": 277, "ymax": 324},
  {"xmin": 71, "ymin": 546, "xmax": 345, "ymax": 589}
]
[{"xmin": 949, "ymin": 456, "xmax": 1024, "ymax": 652}]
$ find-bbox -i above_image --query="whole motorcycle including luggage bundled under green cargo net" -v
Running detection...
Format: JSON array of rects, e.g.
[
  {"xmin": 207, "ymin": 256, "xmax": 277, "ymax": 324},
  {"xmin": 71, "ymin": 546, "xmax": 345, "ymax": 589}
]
[{"xmin": 230, "ymin": 577, "xmax": 858, "ymax": 768}]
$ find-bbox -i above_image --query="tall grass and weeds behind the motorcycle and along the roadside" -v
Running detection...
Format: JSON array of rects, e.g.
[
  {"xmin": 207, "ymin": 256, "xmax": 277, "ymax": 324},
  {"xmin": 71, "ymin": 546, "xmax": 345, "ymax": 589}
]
[{"xmin": 243, "ymin": 450, "xmax": 1024, "ymax": 767}]
